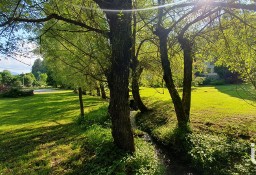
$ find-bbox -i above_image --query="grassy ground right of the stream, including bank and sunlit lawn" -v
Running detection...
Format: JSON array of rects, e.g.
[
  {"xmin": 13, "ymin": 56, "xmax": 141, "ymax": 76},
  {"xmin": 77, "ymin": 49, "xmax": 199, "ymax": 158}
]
[{"xmin": 137, "ymin": 85, "xmax": 256, "ymax": 174}]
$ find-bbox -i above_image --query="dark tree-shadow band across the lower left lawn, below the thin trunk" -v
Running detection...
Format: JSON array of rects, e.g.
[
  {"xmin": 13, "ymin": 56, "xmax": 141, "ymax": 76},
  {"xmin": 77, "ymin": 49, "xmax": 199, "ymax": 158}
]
[{"xmin": 0, "ymin": 124, "xmax": 79, "ymax": 163}]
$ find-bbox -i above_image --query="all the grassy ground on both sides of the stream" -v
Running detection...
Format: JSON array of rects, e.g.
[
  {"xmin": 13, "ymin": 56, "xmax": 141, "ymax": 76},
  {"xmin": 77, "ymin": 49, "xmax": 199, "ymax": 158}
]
[{"xmin": 0, "ymin": 85, "xmax": 256, "ymax": 175}]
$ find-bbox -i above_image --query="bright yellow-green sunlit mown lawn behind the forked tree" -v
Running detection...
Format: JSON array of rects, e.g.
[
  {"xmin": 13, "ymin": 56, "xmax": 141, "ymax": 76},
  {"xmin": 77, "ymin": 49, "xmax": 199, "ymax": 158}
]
[{"xmin": 141, "ymin": 85, "xmax": 256, "ymax": 142}]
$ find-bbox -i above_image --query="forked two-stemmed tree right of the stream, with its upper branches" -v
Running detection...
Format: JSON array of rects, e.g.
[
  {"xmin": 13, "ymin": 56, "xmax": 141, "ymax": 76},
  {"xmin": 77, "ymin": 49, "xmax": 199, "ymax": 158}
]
[{"xmin": 147, "ymin": 0, "xmax": 255, "ymax": 129}]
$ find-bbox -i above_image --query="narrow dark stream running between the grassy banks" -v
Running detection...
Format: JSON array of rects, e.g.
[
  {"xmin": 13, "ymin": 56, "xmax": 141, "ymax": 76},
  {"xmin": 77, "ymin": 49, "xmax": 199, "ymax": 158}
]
[{"xmin": 130, "ymin": 111, "xmax": 196, "ymax": 175}]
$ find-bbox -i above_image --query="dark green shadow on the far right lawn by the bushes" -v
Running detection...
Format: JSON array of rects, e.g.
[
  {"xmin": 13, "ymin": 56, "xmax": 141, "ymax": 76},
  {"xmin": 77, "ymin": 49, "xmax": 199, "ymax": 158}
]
[{"xmin": 215, "ymin": 84, "xmax": 256, "ymax": 102}]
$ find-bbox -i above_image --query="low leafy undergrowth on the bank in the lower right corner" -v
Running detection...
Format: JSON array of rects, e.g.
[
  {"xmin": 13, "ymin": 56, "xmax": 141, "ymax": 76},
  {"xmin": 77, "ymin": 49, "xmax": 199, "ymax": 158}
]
[{"xmin": 189, "ymin": 134, "xmax": 256, "ymax": 175}]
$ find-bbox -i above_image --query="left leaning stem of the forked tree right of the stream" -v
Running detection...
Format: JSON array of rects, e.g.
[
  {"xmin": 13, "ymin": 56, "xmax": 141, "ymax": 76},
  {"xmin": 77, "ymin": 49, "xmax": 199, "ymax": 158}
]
[{"xmin": 155, "ymin": 27, "xmax": 189, "ymax": 128}]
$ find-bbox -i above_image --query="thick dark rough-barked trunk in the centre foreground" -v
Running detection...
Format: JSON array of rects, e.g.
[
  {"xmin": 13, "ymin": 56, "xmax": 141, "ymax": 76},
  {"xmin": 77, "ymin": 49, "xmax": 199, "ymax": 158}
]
[{"xmin": 103, "ymin": 0, "xmax": 135, "ymax": 152}]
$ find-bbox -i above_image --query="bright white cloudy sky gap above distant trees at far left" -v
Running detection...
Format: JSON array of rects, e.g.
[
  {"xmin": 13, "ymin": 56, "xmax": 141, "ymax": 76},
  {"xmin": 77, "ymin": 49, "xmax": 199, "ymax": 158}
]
[{"xmin": 0, "ymin": 43, "xmax": 42, "ymax": 74}]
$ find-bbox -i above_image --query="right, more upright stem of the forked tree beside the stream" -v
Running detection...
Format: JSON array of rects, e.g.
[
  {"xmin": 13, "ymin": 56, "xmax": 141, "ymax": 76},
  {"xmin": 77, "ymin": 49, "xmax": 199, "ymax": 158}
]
[{"xmin": 178, "ymin": 37, "xmax": 193, "ymax": 120}]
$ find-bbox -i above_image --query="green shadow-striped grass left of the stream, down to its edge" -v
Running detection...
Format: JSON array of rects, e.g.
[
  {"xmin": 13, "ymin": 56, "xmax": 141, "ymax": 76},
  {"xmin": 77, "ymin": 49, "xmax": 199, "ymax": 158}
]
[{"xmin": 0, "ymin": 91, "xmax": 163, "ymax": 175}]
